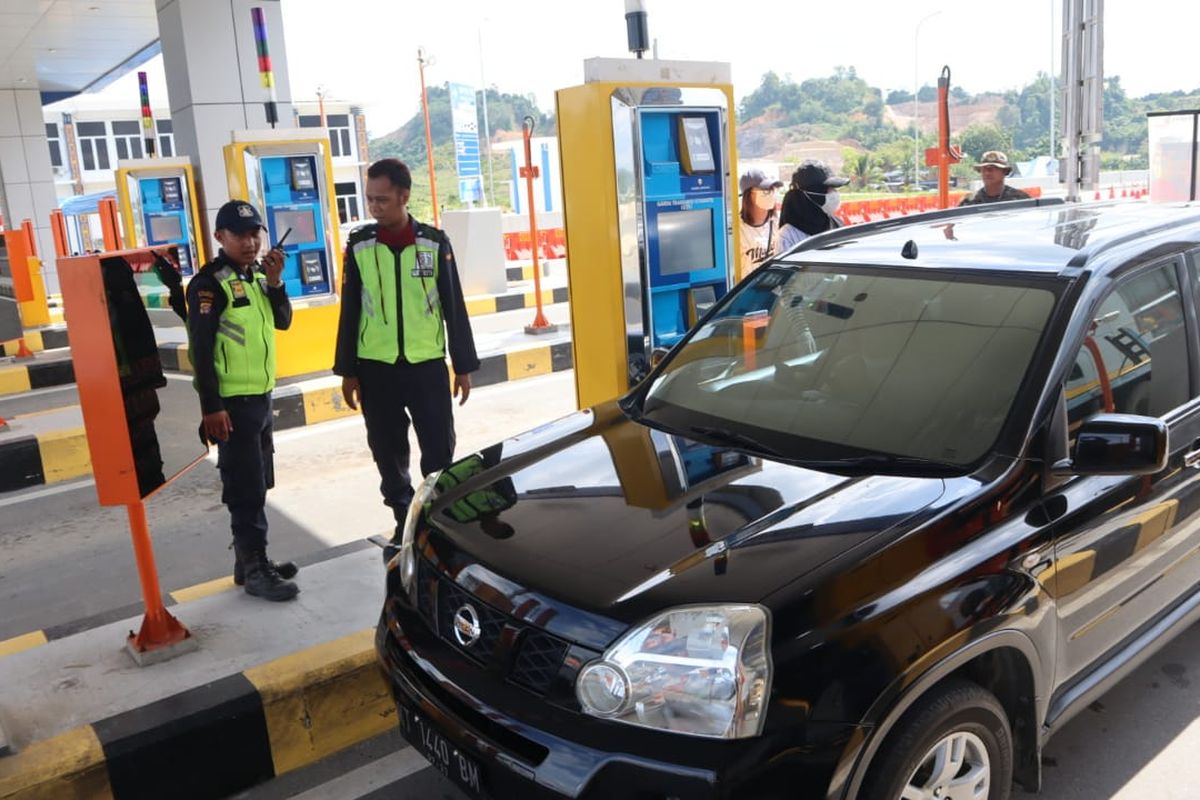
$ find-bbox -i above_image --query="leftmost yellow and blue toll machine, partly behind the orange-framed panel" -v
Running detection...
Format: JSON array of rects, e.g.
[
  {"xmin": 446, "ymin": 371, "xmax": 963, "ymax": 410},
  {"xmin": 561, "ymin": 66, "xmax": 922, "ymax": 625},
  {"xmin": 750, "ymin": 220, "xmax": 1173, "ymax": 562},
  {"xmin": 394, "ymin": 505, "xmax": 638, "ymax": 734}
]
[{"xmin": 116, "ymin": 158, "xmax": 208, "ymax": 278}]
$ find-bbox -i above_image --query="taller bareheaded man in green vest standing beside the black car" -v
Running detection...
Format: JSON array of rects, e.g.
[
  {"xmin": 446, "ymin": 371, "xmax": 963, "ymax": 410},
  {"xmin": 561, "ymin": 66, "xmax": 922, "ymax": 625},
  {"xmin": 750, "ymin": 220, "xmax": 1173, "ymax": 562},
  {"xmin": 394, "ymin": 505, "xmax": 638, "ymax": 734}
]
[{"xmin": 334, "ymin": 158, "xmax": 479, "ymax": 535}]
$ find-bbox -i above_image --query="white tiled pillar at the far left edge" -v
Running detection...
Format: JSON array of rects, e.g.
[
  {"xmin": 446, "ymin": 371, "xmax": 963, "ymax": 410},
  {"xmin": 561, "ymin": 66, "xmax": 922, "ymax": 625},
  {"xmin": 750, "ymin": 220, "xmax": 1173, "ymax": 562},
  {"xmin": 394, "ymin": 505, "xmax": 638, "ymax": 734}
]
[{"xmin": 0, "ymin": 89, "xmax": 59, "ymax": 293}]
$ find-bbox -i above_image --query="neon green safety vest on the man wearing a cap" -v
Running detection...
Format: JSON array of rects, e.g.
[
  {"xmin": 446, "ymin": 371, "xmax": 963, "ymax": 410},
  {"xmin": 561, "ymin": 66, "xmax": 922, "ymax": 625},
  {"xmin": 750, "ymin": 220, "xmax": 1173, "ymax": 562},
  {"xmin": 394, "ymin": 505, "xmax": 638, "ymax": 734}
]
[{"xmin": 212, "ymin": 266, "xmax": 275, "ymax": 397}]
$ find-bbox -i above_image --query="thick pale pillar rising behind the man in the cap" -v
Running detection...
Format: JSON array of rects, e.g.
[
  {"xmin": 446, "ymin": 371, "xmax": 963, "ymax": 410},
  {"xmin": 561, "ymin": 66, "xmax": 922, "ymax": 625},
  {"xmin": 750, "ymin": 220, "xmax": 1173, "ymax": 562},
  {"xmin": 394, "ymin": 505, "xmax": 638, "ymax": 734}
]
[{"xmin": 157, "ymin": 0, "xmax": 295, "ymax": 239}]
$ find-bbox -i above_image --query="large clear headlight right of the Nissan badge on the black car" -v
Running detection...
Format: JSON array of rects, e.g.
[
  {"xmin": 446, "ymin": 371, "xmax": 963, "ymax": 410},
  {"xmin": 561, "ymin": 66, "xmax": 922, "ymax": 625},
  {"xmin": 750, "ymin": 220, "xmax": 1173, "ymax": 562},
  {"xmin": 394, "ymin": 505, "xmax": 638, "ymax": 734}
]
[{"xmin": 575, "ymin": 606, "xmax": 770, "ymax": 739}]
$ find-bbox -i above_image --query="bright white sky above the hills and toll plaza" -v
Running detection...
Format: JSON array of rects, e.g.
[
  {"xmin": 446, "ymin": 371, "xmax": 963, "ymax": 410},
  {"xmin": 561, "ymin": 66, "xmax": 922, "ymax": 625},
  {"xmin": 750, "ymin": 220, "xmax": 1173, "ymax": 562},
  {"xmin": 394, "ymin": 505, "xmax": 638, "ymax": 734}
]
[{"xmin": 77, "ymin": 0, "xmax": 1200, "ymax": 137}]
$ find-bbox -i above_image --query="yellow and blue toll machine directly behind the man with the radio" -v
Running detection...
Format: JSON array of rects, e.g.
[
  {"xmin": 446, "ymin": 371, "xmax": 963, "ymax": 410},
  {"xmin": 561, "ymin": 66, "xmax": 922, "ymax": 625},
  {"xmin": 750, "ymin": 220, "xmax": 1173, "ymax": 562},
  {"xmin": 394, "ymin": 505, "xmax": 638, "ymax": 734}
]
[{"xmin": 224, "ymin": 128, "xmax": 342, "ymax": 378}]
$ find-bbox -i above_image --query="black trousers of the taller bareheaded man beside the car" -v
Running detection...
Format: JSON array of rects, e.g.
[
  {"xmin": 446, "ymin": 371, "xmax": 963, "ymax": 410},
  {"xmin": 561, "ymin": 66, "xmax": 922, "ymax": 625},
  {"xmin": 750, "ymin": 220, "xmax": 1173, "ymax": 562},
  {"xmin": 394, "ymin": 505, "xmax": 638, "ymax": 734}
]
[{"xmin": 358, "ymin": 359, "xmax": 455, "ymax": 523}]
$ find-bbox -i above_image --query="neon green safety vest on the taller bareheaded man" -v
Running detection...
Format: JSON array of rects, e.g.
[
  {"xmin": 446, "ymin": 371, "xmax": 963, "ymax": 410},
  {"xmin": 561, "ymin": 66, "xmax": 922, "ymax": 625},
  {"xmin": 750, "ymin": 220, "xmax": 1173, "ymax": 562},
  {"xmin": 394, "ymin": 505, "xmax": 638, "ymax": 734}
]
[{"xmin": 350, "ymin": 235, "xmax": 445, "ymax": 363}]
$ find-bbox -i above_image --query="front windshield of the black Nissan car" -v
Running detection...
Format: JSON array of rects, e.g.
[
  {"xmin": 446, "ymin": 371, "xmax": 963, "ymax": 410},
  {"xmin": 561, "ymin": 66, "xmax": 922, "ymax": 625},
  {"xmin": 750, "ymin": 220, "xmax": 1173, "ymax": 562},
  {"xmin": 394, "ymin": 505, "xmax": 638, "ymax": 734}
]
[{"xmin": 641, "ymin": 264, "xmax": 1057, "ymax": 468}]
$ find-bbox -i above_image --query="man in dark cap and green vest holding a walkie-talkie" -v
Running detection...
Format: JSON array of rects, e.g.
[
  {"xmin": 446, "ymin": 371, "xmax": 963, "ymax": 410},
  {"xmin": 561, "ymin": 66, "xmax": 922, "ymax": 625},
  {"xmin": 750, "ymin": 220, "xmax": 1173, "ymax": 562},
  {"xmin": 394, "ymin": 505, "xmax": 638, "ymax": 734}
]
[{"xmin": 187, "ymin": 200, "xmax": 300, "ymax": 601}]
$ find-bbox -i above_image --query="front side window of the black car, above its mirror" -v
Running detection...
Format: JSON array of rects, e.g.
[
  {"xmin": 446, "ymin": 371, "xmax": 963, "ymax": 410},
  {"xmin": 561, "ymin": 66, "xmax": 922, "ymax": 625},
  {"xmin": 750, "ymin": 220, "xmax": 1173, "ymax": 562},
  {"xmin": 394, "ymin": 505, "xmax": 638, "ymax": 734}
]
[{"xmin": 1066, "ymin": 261, "xmax": 1190, "ymax": 429}]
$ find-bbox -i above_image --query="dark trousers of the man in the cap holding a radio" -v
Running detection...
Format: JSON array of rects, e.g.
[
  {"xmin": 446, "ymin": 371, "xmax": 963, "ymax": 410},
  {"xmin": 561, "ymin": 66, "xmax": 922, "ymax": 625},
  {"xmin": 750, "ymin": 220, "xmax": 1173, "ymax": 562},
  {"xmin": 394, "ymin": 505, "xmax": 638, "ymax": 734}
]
[{"xmin": 217, "ymin": 393, "xmax": 275, "ymax": 548}]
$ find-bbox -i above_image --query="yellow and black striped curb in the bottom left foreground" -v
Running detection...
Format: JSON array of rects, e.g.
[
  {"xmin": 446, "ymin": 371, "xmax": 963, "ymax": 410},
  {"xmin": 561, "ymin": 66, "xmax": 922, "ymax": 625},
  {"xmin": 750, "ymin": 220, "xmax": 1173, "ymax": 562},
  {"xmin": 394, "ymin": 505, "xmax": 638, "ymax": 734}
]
[{"xmin": 0, "ymin": 628, "xmax": 396, "ymax": 800}]
